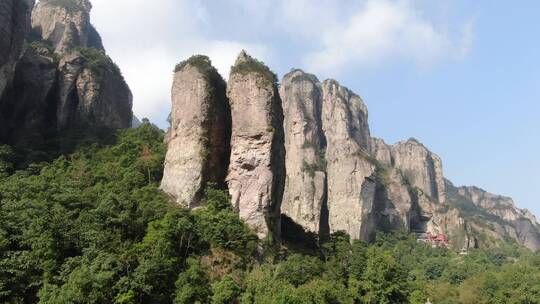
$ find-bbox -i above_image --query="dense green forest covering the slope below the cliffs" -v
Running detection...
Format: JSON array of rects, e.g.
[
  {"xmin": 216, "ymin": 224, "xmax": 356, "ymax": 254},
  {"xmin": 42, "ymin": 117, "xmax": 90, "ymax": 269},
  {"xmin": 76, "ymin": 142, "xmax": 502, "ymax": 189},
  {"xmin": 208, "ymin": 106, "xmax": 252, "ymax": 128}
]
[{"xmin": 0, "ymin": 121, "xmax": 540, "ymax": 304}]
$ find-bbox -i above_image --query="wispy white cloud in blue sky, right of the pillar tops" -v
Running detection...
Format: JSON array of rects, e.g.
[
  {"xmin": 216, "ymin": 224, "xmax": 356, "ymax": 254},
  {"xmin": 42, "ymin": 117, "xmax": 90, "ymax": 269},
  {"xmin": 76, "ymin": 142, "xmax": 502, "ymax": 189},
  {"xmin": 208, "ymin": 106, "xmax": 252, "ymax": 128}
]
[{"xmin": 304, "ymin": 0, "xmax": 473, "ymax": 73}]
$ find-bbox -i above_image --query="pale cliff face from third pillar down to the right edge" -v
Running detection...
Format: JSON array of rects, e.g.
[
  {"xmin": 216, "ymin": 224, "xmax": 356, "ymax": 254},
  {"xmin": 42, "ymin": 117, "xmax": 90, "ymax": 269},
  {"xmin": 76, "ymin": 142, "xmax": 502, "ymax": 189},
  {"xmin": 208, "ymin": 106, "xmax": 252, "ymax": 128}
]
[{"xmin": 274, "ymin": 70, "xmax": 540, "ymax": 250}]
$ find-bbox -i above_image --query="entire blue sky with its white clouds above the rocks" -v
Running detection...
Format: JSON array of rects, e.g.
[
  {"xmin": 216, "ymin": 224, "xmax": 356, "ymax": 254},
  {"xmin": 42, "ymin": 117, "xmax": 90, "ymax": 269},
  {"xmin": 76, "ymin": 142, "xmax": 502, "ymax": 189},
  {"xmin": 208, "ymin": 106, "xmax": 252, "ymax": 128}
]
[{"xmin": 92, "ymin": 0, "xmax": 540, "ymax": 215}]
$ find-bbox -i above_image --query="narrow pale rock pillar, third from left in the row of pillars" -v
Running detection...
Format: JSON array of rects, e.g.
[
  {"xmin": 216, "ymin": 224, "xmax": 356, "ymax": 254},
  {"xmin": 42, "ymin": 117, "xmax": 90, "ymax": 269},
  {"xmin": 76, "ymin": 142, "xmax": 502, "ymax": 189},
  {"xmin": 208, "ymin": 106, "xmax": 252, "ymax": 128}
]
[{"xmin": 280, "ymin": 70, "xmax": 327, "ymax": 233}]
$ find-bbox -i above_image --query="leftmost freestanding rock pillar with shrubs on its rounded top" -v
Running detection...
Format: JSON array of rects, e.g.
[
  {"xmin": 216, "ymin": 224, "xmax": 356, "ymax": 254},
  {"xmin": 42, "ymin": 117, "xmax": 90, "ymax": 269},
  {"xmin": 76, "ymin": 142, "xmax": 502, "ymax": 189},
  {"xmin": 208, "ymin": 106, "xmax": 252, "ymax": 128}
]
[{"xmin": 161, "ymin": 56, "xmax": 231, "ymax": 208}]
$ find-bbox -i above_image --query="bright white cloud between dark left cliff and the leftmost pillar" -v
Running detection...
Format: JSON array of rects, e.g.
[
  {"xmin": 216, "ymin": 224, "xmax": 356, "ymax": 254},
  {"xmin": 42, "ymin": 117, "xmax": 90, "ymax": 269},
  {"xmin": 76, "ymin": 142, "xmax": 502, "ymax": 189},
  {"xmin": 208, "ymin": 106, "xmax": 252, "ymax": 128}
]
[{"xmin": 88, "ymin": 0, "xmax": 269, "ymax": 127}]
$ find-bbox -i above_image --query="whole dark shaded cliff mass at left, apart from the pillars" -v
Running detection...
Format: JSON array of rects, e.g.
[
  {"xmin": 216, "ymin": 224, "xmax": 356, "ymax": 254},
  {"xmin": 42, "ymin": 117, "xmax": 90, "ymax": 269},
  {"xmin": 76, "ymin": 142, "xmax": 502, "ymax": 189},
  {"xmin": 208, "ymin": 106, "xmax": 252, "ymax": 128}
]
[{"xmin": 0, "ymin": 0, "xmax": 132, "ymax": 145}]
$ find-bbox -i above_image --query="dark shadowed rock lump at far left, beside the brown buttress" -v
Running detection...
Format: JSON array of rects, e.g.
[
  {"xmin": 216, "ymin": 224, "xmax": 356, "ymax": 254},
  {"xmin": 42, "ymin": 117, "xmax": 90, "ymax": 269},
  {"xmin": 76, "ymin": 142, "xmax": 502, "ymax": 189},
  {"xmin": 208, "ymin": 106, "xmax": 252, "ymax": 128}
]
[{"xmin": 0, "ymin": 44, "xmax": 57, "ymax": 147}]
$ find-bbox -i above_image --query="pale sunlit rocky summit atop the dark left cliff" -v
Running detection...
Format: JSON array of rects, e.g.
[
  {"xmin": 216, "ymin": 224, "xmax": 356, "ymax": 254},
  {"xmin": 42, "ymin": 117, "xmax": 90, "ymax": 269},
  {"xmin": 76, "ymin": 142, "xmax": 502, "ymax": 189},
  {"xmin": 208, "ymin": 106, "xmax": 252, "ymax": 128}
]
[{"xmin": 32, "ymin": 0, "xmax": 103, "ymax": 54}]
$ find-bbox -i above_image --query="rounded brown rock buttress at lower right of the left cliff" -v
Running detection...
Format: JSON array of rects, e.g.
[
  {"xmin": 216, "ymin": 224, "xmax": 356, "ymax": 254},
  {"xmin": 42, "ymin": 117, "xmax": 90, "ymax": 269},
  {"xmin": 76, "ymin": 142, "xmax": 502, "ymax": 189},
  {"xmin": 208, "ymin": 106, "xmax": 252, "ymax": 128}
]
[{"xmin": 56, "ymin": 49, "xmax": 133, "ymax": 130}]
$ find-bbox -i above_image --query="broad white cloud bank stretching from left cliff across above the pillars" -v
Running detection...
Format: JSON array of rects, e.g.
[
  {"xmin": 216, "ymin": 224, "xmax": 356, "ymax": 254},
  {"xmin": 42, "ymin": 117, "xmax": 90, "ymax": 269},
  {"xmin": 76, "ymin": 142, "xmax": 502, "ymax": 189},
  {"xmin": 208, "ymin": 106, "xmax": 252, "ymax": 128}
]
[{"xmin": 87, "ymin": 0, "xmax": 474, "ymax": 127}]
